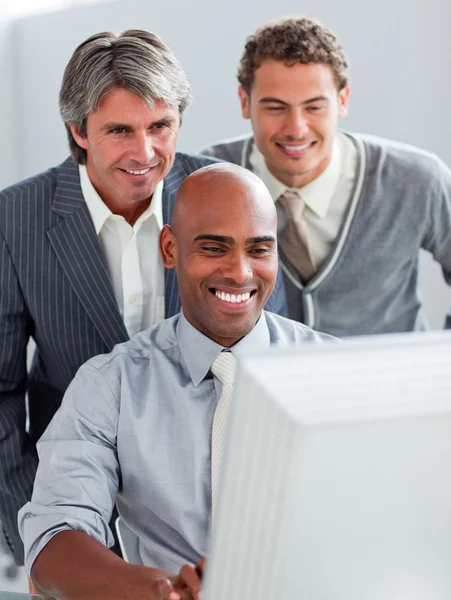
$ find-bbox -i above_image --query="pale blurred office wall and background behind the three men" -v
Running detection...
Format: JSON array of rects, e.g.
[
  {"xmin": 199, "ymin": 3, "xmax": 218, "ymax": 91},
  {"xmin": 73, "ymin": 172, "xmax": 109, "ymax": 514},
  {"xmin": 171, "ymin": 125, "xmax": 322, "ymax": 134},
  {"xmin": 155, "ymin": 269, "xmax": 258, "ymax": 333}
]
[{"xmin": 0, "ymin": 0, "xmax": 451, "ymax": 589}]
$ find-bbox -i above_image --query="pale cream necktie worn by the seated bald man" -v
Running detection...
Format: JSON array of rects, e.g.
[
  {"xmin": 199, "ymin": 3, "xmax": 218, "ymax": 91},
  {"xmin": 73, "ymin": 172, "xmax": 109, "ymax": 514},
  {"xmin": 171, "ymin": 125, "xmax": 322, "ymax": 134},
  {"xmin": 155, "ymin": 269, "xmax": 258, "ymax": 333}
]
[{"xmin": 211, "ymin": 352, "xmax": 236, "ymax": 514}]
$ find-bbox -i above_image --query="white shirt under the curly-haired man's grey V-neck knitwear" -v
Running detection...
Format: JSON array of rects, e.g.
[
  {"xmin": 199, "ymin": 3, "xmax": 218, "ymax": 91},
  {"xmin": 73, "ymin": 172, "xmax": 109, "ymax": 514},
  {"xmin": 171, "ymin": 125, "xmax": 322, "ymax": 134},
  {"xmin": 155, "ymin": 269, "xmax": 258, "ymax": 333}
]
[{"xmin": 249, "ymin": 133, "xmax": 357, "ymax": 268}]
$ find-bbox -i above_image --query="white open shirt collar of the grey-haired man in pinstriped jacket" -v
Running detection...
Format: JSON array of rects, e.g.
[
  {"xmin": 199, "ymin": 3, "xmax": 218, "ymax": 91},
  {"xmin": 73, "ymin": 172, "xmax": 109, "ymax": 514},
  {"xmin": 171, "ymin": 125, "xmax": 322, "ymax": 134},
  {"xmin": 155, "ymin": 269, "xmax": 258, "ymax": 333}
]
[{"xmin": 78, "ymin": 165, "xmax": 164, "ymax": 235}]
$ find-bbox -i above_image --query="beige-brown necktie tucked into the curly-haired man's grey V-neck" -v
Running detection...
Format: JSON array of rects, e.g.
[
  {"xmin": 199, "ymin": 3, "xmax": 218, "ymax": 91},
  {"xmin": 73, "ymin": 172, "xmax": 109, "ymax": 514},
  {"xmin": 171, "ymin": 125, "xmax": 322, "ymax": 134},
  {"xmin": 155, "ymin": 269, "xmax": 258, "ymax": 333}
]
[{"xmin": 279, "ymin": 190, "xmax": 317, "ymax": 281}]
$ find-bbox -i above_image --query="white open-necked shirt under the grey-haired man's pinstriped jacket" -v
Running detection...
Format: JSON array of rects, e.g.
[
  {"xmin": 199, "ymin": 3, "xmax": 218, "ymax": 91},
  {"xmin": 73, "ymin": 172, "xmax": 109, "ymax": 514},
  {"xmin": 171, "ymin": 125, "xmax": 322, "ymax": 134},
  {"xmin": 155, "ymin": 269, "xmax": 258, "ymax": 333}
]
[{"xmin": 79, "ymin": 165, "xmax": 164, "ymax": 337}]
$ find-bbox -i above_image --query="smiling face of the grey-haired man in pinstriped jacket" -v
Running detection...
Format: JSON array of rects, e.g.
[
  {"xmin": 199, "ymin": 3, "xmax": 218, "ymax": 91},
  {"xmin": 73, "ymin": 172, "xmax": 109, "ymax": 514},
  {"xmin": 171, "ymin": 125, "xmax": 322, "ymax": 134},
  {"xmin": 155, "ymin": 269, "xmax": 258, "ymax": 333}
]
[{"xmin": 71, "ymin": 89, "xmax": 180, "ymax": 220}]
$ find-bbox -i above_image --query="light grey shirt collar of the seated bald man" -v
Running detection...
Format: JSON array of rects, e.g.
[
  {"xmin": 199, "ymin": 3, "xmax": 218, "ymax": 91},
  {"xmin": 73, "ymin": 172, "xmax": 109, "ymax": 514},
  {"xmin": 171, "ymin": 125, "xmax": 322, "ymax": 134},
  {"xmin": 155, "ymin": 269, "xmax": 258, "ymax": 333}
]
[{"xmin": 177, "ymin": 311, "xmax": 270, "ymax": 387}]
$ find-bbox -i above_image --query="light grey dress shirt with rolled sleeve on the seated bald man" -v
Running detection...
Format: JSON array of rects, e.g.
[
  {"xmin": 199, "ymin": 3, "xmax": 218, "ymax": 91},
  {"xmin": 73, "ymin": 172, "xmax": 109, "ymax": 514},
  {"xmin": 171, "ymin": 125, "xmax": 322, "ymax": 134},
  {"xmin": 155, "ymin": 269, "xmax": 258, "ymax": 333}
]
[{"xmin": 19, "ymin": 313, "xmax": 328, "ymax": 573}]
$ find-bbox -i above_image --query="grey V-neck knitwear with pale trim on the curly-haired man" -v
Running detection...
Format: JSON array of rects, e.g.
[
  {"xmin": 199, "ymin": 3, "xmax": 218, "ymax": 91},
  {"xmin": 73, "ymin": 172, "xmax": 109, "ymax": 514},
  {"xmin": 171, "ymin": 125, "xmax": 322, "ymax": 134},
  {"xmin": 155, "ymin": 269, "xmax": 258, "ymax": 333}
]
[{"xmin": 202, "ymin": 133, "xmax": 451, "ymax": 337}]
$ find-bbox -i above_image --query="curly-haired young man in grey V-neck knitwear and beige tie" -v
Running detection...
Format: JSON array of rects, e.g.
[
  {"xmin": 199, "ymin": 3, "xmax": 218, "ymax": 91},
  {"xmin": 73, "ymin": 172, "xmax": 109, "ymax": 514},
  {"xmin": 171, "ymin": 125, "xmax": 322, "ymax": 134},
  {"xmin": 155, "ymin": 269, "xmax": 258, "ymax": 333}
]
[{"xmin": 202, "ymin": 18, "xmax": 451, "ymax": 336}]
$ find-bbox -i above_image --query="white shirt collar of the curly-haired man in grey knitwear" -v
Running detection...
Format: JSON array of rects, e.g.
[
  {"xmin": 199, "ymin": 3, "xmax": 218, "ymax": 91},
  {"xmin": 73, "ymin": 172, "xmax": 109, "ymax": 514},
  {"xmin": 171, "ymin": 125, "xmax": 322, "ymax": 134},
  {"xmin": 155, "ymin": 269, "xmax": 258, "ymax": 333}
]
[{"xmin": 249, "ymin": 137, "xmax": 341, "ymax": 219}]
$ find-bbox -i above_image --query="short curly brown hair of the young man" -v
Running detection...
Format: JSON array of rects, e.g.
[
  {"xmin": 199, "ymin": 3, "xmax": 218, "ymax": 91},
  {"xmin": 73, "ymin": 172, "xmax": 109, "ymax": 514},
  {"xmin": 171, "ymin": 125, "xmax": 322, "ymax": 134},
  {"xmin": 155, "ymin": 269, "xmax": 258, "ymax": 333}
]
[{"xmin": 238, "ymin": 17, "xmax": 349, "ymax": 94}]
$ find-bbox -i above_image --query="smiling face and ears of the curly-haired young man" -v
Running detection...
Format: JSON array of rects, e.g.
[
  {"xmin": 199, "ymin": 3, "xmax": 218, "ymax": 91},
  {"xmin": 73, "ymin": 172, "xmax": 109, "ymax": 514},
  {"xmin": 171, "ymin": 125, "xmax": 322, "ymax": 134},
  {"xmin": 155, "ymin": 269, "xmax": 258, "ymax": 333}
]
[{"xmin": 239, "ymin": 60, "xmax": 349, "ymax": 187}]
